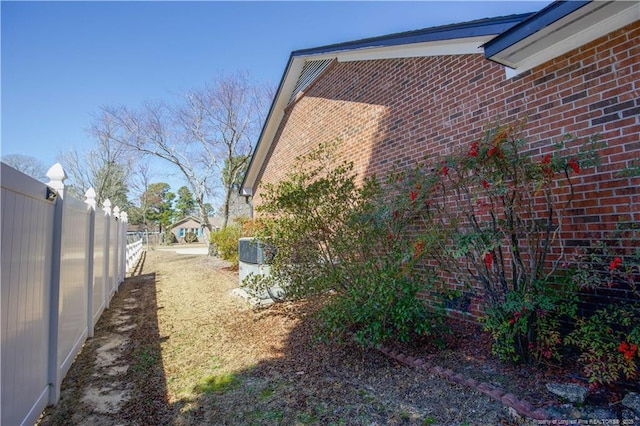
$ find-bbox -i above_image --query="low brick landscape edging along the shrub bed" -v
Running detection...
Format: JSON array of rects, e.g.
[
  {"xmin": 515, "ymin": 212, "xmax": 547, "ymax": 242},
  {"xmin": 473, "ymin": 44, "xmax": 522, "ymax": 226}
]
[{"xmin": 376, "ymin": 345, "xmax": 551, "ymax": 420}]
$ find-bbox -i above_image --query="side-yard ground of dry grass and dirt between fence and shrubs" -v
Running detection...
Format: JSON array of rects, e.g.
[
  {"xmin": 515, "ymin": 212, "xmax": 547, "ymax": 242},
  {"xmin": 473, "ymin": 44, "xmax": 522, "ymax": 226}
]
[{"xmin": 39, "ymin": 251, "xmax": 524, "ymax": 426}]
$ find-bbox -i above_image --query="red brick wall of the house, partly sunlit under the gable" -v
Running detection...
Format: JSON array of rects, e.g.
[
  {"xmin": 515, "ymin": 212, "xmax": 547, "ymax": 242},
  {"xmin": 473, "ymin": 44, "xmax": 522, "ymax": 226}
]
[{"xmin": 254, "ymin": 22, "xmax": 640, "ymax": 316}]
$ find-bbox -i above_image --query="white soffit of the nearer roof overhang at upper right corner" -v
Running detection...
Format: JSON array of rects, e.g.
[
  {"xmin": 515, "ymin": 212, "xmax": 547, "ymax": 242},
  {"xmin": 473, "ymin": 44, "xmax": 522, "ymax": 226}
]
[{"xmin": 500, "ymin": 0, "xmax": 640, "ymax": 76}]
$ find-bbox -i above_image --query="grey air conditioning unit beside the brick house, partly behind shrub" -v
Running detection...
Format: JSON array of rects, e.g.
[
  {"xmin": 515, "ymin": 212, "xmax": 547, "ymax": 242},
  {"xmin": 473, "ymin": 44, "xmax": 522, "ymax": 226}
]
[{"xmin": 238, "ymin": 237, "xmax": 283, "ymax": 301}]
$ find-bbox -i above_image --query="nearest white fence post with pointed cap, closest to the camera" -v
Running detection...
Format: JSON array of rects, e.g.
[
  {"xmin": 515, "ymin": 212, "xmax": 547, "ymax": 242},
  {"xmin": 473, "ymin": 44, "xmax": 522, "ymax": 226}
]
[{"xmin": 47, "ymin": 163, "xmax": 67, "ymax": 404}]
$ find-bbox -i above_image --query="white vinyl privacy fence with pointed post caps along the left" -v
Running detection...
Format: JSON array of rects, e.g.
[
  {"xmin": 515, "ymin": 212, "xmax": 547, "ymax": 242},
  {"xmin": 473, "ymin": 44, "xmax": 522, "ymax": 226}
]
[{"xmin": 0, "ymin": 164, "xmax": 142, "ymax": 426}]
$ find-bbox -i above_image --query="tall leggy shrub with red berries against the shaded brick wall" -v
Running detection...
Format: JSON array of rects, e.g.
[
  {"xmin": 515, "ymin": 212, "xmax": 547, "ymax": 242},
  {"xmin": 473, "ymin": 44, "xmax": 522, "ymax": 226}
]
[{"xmin": 410, "ymin": 120, "xmax": 599, "ymax": 362}]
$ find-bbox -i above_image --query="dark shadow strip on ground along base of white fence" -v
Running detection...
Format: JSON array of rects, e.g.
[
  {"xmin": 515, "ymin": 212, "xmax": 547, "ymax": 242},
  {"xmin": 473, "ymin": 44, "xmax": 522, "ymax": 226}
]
[{"xmin": 38, "ymin": 253, "xmax": 172, "ymax": 426}]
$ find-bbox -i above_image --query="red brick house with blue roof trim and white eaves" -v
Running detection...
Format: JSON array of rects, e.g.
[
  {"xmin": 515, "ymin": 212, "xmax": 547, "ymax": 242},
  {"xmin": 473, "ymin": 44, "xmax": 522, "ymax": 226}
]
[{"xmin": 241, "ymin": 1, "xmax": 640, "ymax": 316}]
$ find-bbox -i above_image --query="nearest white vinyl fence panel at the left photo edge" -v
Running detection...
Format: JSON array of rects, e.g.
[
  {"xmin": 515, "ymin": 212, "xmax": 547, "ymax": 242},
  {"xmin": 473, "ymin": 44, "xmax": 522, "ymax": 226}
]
[{"xmin": 0, "ymin": 164, "xmax": 54, "ymax": 425}]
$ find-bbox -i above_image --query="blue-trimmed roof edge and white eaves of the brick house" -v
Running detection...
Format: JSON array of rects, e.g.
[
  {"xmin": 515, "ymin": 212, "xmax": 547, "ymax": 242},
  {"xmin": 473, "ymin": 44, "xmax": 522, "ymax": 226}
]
[{"xmin": 241, "ymin": 0, "xmax": 640, "ymax": 196}]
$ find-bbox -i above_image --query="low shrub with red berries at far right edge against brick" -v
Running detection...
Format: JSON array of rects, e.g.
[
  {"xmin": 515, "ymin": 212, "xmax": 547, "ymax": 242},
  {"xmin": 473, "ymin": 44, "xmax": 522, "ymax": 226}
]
[{"xmin": 565, "ymin": 230, "xmax": 640, "ymax": 385}]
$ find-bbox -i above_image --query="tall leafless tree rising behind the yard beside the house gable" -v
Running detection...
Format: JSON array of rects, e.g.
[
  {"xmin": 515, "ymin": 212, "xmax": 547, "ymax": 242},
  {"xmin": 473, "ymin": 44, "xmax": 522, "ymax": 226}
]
[{"xmin": 96, "ymin": 73, "xmax": 270, "ymax": 230}]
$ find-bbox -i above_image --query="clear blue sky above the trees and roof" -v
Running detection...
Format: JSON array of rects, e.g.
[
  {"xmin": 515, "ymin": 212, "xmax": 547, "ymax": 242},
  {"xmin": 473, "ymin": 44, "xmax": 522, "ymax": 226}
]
[{"xmin": 0, "ymin": 1, "xmax": 550, "ymax": 190}]
